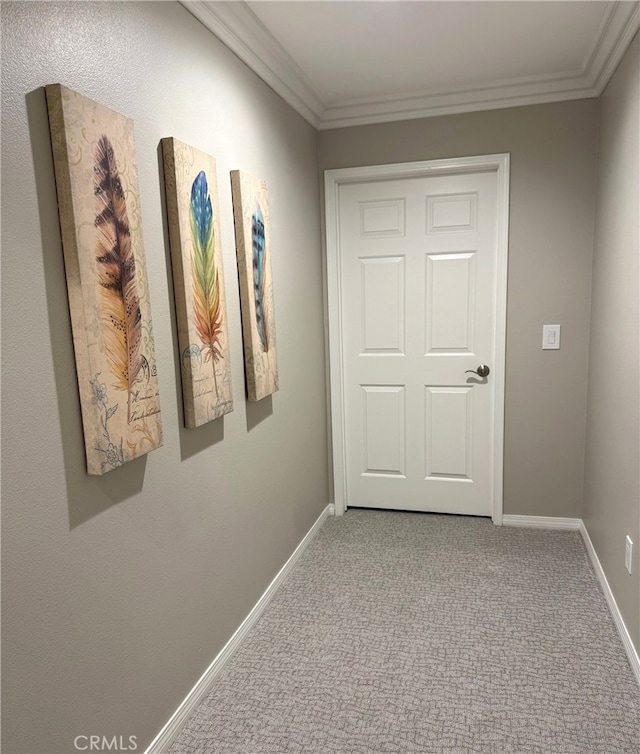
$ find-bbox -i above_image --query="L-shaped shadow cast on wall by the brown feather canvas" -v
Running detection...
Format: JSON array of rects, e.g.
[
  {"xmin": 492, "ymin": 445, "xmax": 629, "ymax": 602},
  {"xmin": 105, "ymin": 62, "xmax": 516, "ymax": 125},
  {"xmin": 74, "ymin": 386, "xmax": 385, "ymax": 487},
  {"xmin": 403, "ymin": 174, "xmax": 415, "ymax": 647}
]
[{"xmin": 25, "ymin": 87, "xmax": 146, "ymax": 529}]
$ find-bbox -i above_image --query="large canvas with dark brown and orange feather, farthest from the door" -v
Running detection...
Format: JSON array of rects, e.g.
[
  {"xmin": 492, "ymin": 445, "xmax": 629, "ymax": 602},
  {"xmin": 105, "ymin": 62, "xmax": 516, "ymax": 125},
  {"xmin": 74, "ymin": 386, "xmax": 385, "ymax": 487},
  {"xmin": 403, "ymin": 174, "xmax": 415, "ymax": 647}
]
[{"xmin": 46, "ymin": 84, "xmax": 162, "ymax": 474}]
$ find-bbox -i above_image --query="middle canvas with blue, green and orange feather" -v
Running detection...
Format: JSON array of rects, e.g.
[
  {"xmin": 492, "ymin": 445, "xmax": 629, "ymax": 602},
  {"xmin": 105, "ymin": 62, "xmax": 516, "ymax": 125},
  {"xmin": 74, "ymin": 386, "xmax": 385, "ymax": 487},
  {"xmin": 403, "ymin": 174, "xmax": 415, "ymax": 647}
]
[{"xmin": 162, "ymin": 138, "xmax": 233, "ymax": 427}]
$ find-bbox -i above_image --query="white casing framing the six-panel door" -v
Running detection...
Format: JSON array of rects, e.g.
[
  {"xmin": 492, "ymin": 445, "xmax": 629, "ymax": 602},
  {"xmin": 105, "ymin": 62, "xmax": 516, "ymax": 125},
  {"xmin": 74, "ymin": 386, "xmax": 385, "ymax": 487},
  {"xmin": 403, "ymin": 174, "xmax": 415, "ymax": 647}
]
[{"xmin": 324, "ymin": 154, "xmax": 509, "ymax": 525}]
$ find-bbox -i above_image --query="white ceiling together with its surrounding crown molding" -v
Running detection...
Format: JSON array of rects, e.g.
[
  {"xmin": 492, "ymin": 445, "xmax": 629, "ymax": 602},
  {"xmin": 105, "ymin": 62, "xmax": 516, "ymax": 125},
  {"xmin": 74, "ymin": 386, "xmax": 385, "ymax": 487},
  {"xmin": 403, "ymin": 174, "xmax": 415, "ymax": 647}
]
[{"xmin": 182, "ymin": 0, "xmax": 640, "ymax": 128}]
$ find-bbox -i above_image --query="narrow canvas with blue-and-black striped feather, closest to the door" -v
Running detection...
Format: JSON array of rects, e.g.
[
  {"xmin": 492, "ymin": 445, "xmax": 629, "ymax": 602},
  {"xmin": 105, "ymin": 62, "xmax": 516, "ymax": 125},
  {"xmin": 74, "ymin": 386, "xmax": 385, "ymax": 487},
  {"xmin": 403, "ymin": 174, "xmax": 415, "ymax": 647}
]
[{"xmin": 231, "ymin": 170, "xmax": 278, "ymax": 401}]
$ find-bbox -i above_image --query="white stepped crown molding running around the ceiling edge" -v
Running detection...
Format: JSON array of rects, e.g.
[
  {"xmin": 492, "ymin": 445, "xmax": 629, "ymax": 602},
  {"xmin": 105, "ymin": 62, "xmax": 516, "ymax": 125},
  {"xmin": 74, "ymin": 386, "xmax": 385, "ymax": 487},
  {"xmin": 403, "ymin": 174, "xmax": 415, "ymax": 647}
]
[{"xmin": 180, "ymin": 0, "xmax": 640, "ymax": 130}]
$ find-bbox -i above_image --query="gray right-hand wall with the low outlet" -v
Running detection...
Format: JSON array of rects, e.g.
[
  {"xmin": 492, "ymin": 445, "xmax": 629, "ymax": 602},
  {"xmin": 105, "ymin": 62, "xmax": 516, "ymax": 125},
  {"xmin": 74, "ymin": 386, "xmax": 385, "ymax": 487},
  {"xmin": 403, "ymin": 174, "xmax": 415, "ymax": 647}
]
[{"xmin": 584, "ymin": 32, "xmax": 640, "ymax": 651}]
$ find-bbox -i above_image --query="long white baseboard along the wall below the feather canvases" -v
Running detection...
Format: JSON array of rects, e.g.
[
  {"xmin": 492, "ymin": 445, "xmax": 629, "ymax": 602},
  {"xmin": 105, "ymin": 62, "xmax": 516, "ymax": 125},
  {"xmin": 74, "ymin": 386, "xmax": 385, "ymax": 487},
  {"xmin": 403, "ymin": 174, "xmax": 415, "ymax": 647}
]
[{"xmin": 145, "ymin": 505, "xmax": 331, "ymax": 754}]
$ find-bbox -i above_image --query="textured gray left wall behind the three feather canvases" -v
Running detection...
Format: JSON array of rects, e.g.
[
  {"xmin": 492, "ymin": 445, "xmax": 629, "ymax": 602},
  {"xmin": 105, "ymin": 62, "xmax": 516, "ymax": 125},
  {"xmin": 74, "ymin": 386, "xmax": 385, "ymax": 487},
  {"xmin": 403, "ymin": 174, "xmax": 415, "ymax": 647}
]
[{"xmin": 2, "ymin": 2, "xmax": 329, "ymax": 754}]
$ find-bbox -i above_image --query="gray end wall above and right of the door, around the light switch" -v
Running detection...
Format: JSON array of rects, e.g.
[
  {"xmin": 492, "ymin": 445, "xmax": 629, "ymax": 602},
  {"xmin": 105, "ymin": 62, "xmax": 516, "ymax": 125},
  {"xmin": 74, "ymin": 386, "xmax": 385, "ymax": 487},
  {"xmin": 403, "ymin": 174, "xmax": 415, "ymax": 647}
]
[{"xmin": 318, "ymin": 100, "xmax": 598, "ymax": 517}]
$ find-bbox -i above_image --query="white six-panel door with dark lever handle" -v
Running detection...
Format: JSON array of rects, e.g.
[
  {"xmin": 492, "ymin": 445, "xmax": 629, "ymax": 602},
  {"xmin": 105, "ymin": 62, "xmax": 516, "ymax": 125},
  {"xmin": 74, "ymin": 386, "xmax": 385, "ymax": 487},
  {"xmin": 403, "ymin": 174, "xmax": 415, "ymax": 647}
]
[{"xmin": 336, "ymin": 163, "xmax": 506, "ymax": 516}]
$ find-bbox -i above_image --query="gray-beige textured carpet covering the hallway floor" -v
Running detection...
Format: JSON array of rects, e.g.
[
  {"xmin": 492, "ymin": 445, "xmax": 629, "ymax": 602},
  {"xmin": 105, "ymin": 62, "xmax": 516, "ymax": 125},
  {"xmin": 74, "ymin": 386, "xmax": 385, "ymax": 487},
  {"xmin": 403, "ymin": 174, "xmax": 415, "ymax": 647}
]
[{"xmin": 170, "ymin": 510, "xmax": 640, "ymax": 754}]
